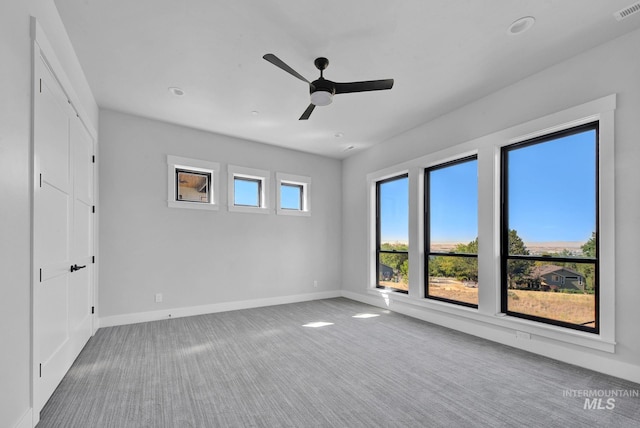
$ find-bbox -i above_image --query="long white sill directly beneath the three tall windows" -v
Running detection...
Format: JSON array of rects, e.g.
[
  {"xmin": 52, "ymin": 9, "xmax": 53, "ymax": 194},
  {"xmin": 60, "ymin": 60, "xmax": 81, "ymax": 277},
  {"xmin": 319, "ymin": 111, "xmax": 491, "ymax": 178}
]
[{"xmin": 367, "ymin": 288, "xmax": 616, "ymax": 353}]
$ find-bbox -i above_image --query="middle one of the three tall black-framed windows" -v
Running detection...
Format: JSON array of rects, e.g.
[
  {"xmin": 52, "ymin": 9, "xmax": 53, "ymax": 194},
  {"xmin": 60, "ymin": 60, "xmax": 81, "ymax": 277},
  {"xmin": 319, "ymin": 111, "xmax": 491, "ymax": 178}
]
[{"xmin": 424, "ymin": 156, "xmax": 478, "ymax": 308}]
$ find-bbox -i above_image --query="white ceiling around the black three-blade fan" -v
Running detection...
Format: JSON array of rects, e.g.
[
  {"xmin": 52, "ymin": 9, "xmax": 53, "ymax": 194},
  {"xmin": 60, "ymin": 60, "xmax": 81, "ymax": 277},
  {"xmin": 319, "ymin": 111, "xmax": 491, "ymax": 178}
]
[{"xmin": 55, "ymin": 0, "xmax": 640, "ymax": 158}]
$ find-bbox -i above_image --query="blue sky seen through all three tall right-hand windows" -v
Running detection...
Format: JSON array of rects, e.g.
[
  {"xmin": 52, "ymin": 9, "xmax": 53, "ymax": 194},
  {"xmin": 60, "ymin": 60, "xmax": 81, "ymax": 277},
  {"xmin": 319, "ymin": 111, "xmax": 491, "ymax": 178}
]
[{"xmin": 380, "ymin": 131, "xmax": 596, "ymax": 243}]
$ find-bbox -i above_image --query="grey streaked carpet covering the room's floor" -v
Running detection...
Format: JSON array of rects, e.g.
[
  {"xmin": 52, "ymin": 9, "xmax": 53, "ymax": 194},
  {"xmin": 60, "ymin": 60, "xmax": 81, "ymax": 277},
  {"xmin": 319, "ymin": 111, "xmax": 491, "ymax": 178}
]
[{"xmin": 38, "ymin": 298, "xmax": 640, "ymax": 428}]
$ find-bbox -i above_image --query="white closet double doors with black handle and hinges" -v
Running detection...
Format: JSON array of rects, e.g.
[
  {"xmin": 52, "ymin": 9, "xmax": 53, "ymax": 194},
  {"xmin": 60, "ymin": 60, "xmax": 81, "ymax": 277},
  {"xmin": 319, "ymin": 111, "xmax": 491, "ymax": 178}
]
[{"xmin": 33, "ymin": 58, "xmax": 93, "ymax": 412}]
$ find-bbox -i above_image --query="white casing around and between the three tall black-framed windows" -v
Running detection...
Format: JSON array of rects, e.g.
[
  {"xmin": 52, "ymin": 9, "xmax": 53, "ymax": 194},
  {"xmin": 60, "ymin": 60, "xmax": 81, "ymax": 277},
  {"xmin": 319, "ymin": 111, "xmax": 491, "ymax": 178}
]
[{"xmin": 366, "ymin": 94, "xmax": 617, "ymax": 353}]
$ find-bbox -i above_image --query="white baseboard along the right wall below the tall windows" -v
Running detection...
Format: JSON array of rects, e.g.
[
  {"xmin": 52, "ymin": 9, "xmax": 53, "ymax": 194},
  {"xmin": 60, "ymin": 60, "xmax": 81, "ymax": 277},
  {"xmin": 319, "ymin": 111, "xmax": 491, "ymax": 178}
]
[{"xmin": 342, "ymin": 290, "xmax": 640, "ymax": 383}]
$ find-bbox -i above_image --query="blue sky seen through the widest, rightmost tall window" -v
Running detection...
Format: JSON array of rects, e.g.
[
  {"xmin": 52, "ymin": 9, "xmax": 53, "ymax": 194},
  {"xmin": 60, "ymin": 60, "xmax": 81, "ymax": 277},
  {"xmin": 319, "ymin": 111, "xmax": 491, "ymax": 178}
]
[{"xmin": 509, "ymin": 131, "xmax": 596, "ymax": 242}]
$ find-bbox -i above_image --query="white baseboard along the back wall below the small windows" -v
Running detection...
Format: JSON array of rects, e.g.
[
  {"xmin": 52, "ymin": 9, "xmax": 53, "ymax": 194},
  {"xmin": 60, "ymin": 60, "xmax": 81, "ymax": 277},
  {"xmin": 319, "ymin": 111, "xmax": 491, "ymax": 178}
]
[{"xmin": 98, "ymin": 290, "xmax": 342, "ymax": 328}]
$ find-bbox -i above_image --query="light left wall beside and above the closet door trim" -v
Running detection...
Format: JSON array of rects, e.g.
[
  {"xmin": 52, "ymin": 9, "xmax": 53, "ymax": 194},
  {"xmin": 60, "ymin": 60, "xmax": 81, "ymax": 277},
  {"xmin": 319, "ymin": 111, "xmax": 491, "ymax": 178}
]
[{"xmin": 0, "ymin": 0, "xmax": 98, "ymax": 427}]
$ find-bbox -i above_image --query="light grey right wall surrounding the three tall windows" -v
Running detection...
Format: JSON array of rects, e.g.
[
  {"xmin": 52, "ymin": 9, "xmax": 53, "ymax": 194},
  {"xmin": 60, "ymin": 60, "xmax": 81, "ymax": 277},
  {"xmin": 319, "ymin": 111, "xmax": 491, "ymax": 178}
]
[{"xmin": 342, "ymin": 31, "xmax": 640, "ymax": 382}]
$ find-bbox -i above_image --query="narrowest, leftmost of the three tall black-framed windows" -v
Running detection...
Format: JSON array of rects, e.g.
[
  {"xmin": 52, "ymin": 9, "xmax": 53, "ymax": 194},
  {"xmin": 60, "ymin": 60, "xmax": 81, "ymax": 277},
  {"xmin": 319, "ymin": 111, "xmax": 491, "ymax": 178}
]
[{"xmin": 376, "ymin": 174, "xmax": 409, "ymax": 293}]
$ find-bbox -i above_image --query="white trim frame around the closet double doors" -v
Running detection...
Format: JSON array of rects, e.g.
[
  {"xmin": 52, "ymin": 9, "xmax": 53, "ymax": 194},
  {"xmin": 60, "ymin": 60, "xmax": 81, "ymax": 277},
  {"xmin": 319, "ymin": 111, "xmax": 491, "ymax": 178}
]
[{"xmin": 29, "ymin": 17, "xmax": 99, "ymax": 427}]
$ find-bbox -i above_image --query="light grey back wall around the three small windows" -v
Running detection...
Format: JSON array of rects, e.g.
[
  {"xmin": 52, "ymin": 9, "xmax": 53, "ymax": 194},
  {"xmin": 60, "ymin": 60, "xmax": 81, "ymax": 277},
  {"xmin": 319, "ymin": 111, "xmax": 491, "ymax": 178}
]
[{"xmin": 98, "ymin": 110, "xmax": 342, "ymax": 325}]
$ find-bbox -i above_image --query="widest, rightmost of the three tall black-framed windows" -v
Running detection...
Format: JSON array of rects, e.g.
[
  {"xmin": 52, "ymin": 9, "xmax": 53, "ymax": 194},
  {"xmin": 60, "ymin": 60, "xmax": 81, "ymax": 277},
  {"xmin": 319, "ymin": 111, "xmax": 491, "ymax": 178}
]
[{"xmin": 501, "ymin": 122, "xmax": 599, "ymax": 333}]
